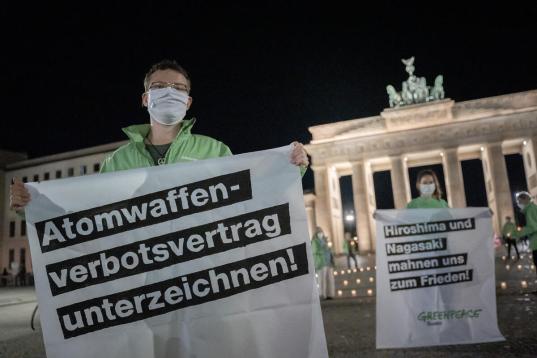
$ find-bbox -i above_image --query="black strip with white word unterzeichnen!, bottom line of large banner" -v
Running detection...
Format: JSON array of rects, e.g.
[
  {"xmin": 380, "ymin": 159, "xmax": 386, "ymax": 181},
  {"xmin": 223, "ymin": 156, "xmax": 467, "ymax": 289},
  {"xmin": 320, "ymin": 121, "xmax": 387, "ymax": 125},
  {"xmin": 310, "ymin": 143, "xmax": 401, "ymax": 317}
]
[{"xmin": 57, "ymin": 243, "xmax": 308, "ymax": 339}]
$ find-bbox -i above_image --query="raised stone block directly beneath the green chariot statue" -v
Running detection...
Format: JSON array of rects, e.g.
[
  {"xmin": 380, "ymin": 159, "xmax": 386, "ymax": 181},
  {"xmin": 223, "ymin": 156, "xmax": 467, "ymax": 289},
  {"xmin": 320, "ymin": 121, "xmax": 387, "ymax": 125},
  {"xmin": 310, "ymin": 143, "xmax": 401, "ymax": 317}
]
[{"xmin": 380, "ymin": 99, "xmax": 455, "ymax": 132}]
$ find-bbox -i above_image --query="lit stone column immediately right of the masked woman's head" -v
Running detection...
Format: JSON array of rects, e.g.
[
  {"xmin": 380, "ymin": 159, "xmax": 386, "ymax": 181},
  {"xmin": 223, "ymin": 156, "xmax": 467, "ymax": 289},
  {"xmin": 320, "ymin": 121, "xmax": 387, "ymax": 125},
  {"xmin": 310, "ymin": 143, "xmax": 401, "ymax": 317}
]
[{"xmin": 442, "ymin": 148, "xmax": 466, "ymax": 208}]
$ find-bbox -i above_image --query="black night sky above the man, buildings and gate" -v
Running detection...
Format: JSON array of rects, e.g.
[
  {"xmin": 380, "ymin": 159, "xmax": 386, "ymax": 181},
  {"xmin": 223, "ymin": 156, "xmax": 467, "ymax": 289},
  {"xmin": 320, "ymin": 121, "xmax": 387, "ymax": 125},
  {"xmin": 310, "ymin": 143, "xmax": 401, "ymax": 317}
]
[{"xmin": 0, "ymin": 1, "xmax": 537, "ymax": 203}]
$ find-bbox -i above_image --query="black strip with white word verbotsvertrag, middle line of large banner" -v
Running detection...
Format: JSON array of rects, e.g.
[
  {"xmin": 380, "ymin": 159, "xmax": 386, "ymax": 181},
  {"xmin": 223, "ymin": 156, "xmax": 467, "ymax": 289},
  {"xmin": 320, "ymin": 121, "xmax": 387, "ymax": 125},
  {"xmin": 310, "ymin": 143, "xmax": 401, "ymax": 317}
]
[{"xmin": 46, "ymin": 204, "xmax": 291, "ymax": 296}]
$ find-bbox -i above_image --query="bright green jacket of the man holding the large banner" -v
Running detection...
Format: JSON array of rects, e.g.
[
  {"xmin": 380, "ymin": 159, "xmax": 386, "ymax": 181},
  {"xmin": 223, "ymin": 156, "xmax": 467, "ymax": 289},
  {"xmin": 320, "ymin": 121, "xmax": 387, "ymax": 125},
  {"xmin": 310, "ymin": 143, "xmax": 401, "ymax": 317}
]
[{"xmin": 101, "ymin": 119, "xmax": 231, "ymax": 173}]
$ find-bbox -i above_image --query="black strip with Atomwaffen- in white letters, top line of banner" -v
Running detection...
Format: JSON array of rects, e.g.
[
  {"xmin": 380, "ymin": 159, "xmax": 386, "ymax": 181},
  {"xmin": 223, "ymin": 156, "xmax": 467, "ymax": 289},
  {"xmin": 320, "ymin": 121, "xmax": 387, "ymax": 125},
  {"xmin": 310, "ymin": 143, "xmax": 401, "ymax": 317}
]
[{"xmin": 35, "ymin": 170, "xmax": 252, "ymax": 253}]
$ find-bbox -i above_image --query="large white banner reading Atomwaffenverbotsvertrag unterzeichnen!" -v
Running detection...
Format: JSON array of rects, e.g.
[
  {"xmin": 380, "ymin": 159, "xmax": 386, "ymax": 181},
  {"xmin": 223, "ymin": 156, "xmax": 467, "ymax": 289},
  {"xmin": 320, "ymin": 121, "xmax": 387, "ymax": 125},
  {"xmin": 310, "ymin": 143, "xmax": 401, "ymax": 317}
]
[{"xmin": 26, "ymin": 147, "xmax": 328, "ymax": 358}]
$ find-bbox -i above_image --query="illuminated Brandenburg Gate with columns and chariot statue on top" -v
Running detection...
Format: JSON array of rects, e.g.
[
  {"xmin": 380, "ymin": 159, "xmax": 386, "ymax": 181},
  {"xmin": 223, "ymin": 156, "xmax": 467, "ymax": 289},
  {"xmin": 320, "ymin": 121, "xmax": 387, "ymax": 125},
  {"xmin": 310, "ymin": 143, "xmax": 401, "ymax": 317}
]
[{"xmin": 305, "ymin": 58, "xmax": 537, "ymax": 253}]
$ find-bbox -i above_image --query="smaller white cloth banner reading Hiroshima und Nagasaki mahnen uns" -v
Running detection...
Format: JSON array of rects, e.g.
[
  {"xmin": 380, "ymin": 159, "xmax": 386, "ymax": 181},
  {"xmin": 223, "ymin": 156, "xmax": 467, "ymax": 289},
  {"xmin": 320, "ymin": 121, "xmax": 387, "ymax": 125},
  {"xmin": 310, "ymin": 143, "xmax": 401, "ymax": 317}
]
[{"xmin": 375, "ymin": 208, "xmax": 504, "ymax": 348}]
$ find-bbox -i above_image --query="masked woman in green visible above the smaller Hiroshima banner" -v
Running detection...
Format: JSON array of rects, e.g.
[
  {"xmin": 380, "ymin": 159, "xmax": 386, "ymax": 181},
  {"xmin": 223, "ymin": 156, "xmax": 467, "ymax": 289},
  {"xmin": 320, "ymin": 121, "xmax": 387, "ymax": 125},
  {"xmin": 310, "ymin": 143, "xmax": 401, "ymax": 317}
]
[{"xmin": 406, "ymin": 169, "xmax": 449, "ymax": 209}]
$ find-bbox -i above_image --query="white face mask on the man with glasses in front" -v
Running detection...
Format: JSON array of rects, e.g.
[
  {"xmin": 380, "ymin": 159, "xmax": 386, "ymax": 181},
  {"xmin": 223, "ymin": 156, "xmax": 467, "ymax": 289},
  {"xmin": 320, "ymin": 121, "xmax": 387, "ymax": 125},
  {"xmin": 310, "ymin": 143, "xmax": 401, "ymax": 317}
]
[{"xmin": 147, "ymin": 87, "xmax": 188, "ymax": 126}]
